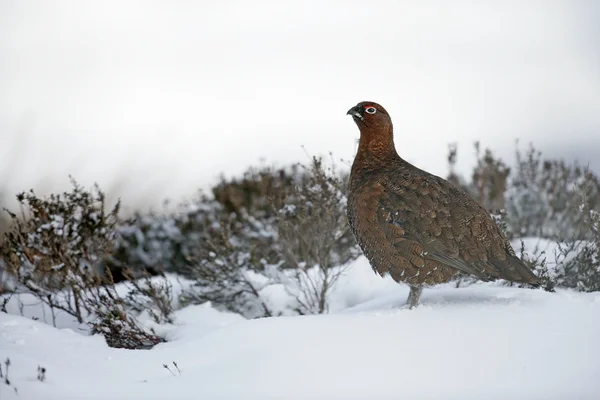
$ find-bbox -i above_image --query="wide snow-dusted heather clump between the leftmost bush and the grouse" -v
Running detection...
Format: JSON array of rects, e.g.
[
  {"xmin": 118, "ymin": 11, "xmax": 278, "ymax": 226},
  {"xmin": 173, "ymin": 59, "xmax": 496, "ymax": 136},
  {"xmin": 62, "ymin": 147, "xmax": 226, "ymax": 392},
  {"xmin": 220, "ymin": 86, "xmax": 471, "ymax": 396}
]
[{"xmin": 111, "ymin": 159, "xmax": 359, "ymax": 318}]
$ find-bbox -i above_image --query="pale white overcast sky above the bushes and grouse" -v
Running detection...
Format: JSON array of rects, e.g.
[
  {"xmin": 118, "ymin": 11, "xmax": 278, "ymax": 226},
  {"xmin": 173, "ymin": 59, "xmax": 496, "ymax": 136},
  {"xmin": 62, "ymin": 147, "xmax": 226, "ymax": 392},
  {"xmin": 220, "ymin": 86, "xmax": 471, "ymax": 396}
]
[{"xmin": 0, "ymin": 0, "xmax": 600, "ymax": 212}]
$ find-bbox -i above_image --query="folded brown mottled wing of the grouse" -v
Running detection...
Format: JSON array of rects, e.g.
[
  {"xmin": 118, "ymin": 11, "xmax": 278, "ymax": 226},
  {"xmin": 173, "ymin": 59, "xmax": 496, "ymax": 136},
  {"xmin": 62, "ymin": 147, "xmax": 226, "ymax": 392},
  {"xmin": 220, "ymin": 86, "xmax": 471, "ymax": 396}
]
[{"xmin": 378, "ymin": 175, "xmax": 534, "ymax": 281}]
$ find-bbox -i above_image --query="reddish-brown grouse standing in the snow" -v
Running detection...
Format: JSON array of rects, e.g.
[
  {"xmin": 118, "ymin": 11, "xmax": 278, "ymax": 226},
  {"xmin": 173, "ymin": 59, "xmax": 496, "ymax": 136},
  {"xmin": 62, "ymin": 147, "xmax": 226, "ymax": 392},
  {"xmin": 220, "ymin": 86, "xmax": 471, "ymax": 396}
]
[{"xmin": 347, "ymin": 101, "xmax": 540, "ymax": 309}]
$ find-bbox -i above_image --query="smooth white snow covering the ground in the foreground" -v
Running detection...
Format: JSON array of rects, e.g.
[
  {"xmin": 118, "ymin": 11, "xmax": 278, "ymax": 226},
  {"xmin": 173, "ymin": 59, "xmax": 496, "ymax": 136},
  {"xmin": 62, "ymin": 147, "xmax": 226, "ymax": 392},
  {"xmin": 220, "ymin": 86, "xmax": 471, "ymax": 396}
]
[{"xmin": 0, "ymin": 258, "xmax": 600, "ymax": 400}]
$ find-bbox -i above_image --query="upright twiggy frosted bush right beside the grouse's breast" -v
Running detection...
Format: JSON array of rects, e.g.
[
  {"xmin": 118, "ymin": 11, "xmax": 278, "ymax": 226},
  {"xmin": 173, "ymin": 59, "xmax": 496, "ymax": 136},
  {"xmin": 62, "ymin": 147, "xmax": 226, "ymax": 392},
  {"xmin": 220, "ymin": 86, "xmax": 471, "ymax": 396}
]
[{"xmin": 276, "ymin": 157, "xmax": 360, "ymax": 314}]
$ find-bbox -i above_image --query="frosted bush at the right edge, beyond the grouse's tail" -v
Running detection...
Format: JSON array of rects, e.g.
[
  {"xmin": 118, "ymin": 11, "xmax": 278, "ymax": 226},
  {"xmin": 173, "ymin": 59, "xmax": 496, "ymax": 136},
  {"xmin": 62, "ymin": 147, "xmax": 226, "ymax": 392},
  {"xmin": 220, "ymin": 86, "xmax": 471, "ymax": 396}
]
[{"xmin": 506, "ymin": 147, "xmax": 600, "ymax": 291}]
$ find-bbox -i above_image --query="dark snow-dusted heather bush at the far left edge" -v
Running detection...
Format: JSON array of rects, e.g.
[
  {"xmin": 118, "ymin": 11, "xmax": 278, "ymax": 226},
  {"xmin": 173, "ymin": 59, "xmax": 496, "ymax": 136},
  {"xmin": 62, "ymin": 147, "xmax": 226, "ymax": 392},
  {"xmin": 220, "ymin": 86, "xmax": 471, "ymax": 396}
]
[{"xmin": 0, "ymin": 181, "xmax": 166, "ymax": 348}]
